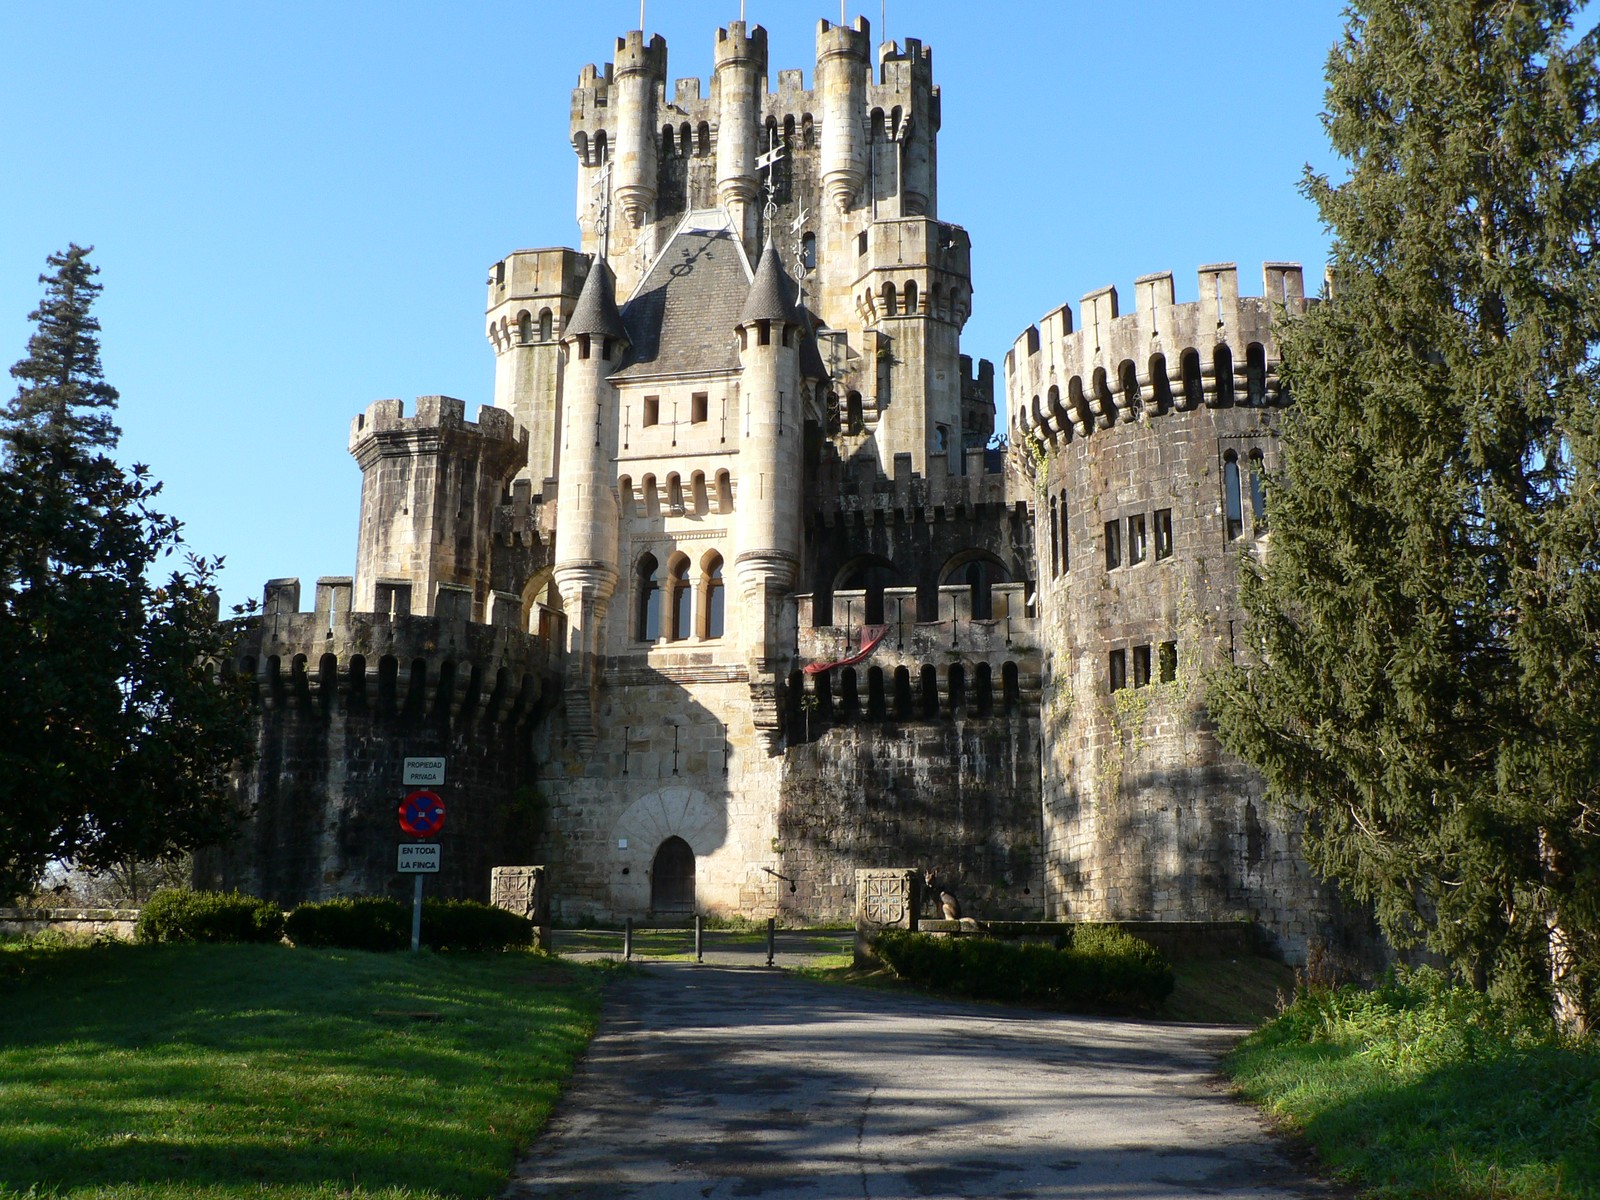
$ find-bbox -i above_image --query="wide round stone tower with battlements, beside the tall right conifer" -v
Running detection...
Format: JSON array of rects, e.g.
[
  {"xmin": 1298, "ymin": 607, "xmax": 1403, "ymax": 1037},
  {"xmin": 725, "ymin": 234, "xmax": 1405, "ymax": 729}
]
[{"xmin": 1005, "ymin": 262, "xmax": 1341, "ymax": 955}]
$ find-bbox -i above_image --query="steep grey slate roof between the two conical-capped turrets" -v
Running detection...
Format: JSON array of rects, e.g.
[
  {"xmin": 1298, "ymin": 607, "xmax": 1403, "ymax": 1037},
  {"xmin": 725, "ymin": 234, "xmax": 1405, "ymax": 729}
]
[{"xmin": 611, "ymin": 227, "xmax": 750, "ymax": 379}]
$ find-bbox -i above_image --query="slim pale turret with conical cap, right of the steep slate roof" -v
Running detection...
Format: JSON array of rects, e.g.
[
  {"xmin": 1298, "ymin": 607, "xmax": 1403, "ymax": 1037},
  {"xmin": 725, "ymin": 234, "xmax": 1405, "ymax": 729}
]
[{"xmin": 736, "ymin": 240, "xmax": 805, "ymax": 670}]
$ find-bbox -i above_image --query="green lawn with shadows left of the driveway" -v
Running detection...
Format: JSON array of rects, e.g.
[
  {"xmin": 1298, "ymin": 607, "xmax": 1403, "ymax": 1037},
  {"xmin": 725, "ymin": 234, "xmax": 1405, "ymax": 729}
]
[{"xmin": 0, "ymin": 944, "xmax": 606, "ymax": 1200}]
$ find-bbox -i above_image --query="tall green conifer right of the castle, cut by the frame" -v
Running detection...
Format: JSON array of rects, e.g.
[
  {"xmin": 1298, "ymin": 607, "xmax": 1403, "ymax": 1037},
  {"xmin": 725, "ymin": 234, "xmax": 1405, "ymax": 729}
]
[{"xmin": 1211, "ymin": 0, "xmax": 1600, "ymax": 1018}]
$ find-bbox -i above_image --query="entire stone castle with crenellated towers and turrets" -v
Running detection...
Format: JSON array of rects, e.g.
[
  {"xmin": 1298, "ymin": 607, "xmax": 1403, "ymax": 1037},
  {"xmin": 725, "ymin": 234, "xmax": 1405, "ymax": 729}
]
[{"xmin": 200, "ymin": 19, "xmax": 1338, "ymax": 958}]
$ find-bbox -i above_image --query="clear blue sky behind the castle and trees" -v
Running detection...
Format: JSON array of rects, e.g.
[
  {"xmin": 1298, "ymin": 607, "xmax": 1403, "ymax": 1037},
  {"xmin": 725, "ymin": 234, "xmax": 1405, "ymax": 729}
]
[{"xmin": 0, "ymin": 0, "xmax": 1342, "ymax": 603}]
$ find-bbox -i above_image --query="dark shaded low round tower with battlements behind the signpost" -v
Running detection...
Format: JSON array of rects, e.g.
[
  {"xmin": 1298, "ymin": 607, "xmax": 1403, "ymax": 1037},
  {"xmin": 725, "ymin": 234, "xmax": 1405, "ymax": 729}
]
[{"xmin": 195, "ymin": 611, "xmax": 547, "ymax": 907}]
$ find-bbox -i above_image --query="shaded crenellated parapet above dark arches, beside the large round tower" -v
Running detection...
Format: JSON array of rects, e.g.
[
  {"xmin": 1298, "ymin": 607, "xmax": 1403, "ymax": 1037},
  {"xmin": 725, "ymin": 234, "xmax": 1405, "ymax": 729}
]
[{"xmin": 810, "ymin": 450, "xmax": 1010, "ymax": 528}]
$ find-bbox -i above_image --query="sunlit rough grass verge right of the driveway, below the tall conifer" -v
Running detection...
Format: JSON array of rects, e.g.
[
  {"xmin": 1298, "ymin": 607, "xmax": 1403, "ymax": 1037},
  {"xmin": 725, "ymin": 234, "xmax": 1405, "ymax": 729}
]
[{"xmin": 1229, "ymin": 971, "xmax": 1600, "ymax": 1200}]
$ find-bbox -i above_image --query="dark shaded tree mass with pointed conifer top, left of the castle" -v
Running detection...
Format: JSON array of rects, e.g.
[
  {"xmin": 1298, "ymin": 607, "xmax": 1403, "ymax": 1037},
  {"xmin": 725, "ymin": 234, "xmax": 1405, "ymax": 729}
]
[{"xmin": 0, "ymin": 246, "xmax": 248, "ymax": 896}]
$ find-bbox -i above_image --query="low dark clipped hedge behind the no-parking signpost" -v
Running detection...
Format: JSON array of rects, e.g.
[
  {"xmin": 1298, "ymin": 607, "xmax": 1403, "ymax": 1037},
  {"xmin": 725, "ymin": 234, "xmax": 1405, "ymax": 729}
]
[{"xmin": 286, "ymin": 896, "xmax": 534, "ymax": 950}]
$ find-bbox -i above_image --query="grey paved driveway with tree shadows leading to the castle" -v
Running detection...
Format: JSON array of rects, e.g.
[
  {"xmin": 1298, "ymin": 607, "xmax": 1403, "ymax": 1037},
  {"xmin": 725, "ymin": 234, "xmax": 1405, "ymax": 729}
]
[{"xmin": 506, "ymin": 962, "xmax": 1338, "ymax": 1200}]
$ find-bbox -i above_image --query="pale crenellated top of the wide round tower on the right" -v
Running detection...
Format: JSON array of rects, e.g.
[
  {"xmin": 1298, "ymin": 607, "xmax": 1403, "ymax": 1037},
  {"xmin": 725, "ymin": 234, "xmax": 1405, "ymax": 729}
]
[{"xmin": 1005, "ymin": 262, "xmax": 1315, "ymax": 446}]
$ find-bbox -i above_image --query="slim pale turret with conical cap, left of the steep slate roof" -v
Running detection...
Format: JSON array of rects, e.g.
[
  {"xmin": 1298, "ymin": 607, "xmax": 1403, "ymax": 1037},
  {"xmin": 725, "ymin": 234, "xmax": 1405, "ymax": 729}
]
[{"xmin": 554, "ymin": 258, "xmax": 627, "ymax": 750}]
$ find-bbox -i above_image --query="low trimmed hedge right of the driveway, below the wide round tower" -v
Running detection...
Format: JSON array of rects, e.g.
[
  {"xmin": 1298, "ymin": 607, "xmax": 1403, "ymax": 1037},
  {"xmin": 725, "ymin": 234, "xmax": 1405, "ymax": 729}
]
[{"xmin": 874, "ymin": 925, "xmax": 1173, "ymax": 1008}]
